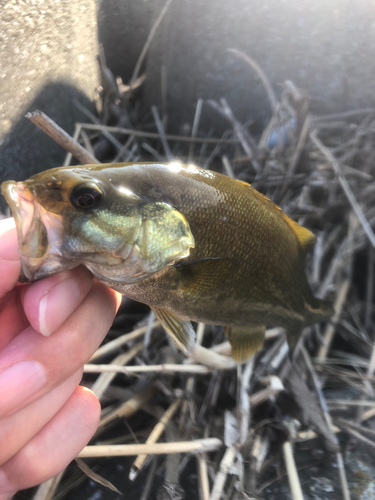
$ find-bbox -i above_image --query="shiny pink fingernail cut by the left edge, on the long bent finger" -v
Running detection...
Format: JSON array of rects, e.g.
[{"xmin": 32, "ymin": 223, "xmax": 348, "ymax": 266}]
[{"xmin": 0, "ymin": 361, "xmax": 47, "ymax": 415}]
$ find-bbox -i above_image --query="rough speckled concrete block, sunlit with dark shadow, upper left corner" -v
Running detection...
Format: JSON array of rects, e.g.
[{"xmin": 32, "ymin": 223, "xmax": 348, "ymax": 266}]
[{"xmin": 0, "ymin": 0, "xmax": 98, "ymax": 206}]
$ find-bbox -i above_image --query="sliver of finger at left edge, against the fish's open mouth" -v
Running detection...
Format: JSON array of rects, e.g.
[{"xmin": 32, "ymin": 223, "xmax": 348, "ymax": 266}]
[{"xmin": 0, "ymin": 218, "xmax": 21, "ymax": 299}]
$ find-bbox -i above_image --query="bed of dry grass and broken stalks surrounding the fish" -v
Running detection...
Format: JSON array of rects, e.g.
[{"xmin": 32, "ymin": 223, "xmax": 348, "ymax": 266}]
[{"xmin": 21, "ymin": 45, "xmax": 375, "ymax": 500}]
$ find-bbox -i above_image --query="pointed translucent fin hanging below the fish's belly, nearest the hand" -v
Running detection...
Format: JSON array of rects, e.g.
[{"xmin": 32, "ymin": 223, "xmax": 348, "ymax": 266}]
[{"xmin": 151, "ymin": 307, "xmax": 195, "ymax": 353}]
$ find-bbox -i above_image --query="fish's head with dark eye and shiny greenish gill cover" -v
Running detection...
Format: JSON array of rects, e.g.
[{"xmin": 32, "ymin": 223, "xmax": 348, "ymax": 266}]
[{"xmin": 2, "ymin": 166, "xmax": 195, "ymax": 285}]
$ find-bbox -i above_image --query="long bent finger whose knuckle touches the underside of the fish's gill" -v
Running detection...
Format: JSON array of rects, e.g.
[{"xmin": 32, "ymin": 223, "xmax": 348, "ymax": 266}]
[{"xmin": 0, "ymin": 282, "xmax": 121, "ymax": 416}]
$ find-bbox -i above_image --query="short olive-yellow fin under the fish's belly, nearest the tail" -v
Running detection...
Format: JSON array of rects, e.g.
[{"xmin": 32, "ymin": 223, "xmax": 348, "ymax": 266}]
[{"xmin": 226, "ymin": 325, "xmax": 266, "ymax": 363}]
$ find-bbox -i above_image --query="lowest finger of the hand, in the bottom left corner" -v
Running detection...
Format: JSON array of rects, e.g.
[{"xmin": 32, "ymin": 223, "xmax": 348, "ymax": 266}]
[{"xmin": 0, "ymin": 387, "xmax": 100, "ymax": 498}]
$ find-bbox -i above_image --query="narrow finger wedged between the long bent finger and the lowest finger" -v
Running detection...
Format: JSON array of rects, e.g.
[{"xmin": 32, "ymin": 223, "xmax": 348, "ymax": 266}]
[{"xmin": 0, "ymin": 370, "xmax": 82, "ymax": 464}]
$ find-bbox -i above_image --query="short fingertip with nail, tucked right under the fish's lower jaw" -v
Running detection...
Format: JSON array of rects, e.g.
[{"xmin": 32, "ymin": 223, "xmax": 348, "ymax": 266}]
[{"xmin": 23, "ymin": 267, "xmax": 93, "ymax": 336}]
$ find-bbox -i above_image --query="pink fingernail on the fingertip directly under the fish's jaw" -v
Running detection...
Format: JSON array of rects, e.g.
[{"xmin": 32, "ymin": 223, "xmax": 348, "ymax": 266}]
[{"xmin": 39, "ymin": 278, "xmax": 81, "ymax": 337}]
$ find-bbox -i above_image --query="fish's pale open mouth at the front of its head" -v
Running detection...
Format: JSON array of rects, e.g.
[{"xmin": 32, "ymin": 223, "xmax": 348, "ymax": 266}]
[{"xmin": 1, "ymin": 181, "xmax": 61, "ymax": 283}]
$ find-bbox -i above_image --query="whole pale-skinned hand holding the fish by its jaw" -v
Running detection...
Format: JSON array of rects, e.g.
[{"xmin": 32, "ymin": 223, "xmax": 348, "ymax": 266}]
[{"xmin": 0, "ymin": 219, "xmax": 121, "ymax": 500}]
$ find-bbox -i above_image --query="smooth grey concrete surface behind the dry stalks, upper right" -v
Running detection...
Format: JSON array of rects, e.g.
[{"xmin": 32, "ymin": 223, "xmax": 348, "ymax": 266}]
[{"xmin": 99, "ymin": 0, "xmax": 375, "ymax": 132}]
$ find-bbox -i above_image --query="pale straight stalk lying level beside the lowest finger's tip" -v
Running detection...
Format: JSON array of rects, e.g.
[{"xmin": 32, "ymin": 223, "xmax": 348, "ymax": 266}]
[{"xmin": 78, "ymin": 438, "xmax": 223, "ymax": 458}]
